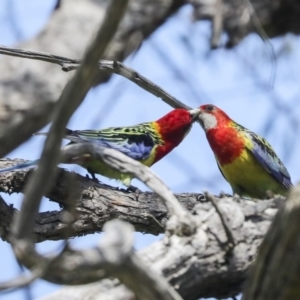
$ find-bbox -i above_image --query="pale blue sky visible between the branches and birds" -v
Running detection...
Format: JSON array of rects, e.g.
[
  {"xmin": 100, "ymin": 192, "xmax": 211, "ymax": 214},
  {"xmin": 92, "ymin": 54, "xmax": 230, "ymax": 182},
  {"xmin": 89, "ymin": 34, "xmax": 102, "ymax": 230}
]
[{"xmin": 0, "ymin": 0, "xmax": 300, "ymax": 300}]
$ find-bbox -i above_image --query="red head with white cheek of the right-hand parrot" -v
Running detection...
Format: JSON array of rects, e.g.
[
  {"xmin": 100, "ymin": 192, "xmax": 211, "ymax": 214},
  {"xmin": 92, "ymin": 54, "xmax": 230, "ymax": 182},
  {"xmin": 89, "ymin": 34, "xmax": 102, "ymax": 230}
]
[{"xmin": 199, "ymin": 104, "xmax": 231, "ymax": 132}]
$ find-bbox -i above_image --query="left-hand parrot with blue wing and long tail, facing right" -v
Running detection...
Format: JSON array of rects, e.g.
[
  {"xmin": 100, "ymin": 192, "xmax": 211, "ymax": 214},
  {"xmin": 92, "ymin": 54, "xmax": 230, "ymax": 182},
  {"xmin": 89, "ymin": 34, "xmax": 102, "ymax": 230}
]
[{"xmin": 0, "ymin": 108, "xmax": 200, "ymax": 187}]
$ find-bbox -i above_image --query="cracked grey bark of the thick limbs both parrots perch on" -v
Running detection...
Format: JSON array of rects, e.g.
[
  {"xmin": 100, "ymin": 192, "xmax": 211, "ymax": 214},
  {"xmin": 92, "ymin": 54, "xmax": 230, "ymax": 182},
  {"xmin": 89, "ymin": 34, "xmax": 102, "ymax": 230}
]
[{"xmin": 0, "ymin": 160, "xmax": 282, "ymax": 299}]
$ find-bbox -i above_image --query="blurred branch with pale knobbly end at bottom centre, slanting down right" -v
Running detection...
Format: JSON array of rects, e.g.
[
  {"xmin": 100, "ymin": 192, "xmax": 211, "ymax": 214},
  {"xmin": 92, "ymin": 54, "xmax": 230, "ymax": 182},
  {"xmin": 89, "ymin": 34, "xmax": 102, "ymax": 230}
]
[{"xmin": 95, "ymin": 220, "xmax": 182, "ymax": 300}]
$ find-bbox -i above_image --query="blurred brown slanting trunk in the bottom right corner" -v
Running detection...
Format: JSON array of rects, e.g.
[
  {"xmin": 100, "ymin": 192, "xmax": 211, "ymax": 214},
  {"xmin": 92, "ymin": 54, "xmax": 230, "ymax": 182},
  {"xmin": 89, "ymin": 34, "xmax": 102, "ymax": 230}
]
[{"xmin": 243, "ymin": 185, "xmax": 300, "ymax": 300}]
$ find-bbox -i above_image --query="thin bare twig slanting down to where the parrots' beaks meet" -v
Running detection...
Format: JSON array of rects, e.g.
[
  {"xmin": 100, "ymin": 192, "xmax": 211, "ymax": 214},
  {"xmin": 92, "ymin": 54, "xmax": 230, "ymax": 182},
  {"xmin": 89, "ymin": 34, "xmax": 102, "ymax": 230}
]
[{"xmin": 0, "ymin": 46, "xmax": 191, "ymax": 109}]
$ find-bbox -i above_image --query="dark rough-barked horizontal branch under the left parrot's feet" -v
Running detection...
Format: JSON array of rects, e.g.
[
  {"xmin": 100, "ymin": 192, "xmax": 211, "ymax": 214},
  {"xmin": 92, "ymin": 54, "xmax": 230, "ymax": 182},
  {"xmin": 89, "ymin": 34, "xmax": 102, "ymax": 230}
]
[{"xmin": 0, "ymin": 159, "xmax": 284, "ymax": 242}]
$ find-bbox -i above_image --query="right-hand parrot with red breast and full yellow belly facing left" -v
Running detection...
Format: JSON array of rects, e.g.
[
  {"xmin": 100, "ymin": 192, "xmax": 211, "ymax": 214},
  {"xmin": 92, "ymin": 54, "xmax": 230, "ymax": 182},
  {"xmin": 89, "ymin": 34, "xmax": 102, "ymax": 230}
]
[{"xmin": 198, "ymin": 104, "xmax": 293, "ymax": 199}]
